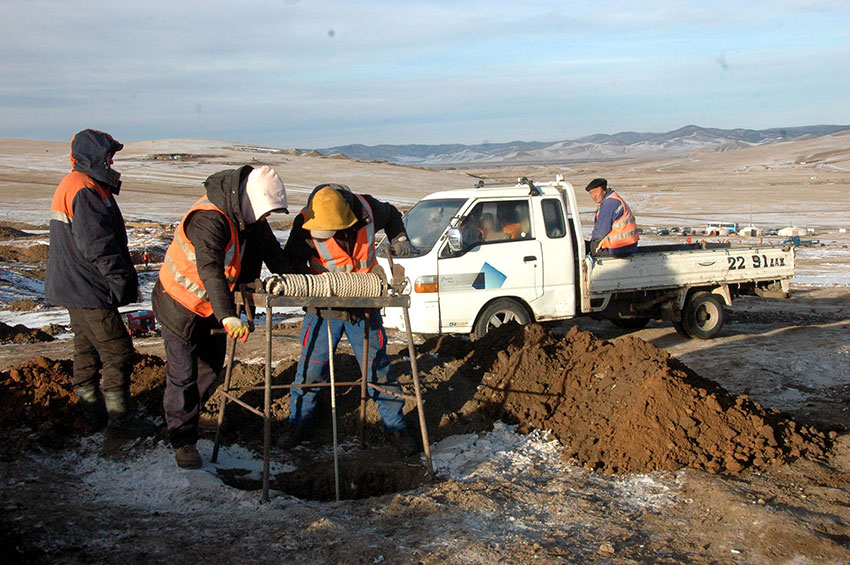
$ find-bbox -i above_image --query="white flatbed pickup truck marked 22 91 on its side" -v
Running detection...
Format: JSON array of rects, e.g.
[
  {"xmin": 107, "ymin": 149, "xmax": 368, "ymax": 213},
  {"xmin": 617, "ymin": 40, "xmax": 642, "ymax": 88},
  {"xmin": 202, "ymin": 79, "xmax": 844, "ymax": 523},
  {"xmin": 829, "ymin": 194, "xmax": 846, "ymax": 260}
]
[{"xmin": 379, "ymin": 175, "xmax": 794, "ymax": 339}]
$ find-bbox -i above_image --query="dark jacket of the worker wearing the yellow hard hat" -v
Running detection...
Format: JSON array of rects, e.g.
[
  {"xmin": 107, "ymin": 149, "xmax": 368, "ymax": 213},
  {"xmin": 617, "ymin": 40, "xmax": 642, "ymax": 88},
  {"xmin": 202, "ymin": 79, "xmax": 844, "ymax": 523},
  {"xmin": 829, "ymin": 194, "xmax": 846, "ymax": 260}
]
[{"xmin": 284, "ymin": 185, "xmax": 407, "ymax": 322}]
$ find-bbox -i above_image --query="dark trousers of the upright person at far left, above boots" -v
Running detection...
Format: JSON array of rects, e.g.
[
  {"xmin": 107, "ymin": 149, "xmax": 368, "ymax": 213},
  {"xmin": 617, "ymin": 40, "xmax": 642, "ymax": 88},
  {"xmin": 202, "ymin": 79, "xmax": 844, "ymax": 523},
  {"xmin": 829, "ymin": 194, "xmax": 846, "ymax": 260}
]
[{"xmin": 68, "ymin": 308, "xmax": 134, "ymax": 392}]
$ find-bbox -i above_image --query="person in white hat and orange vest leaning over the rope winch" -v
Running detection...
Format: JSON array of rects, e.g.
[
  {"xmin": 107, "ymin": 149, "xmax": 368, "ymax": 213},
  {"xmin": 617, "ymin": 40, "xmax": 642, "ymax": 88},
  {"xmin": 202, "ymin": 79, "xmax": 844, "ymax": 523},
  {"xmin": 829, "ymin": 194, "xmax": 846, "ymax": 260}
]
[{"xmin": 152, "ymin": 165, "xmax": 288, "ymax": 469}]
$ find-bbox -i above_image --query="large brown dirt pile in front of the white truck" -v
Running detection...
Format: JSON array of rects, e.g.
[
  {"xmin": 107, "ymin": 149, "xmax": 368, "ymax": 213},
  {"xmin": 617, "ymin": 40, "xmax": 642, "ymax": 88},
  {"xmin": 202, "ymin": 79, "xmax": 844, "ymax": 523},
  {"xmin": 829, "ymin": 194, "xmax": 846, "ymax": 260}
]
[{"xmin": 467, "ymin": 324, "xmax": 834, "ymax": 473}]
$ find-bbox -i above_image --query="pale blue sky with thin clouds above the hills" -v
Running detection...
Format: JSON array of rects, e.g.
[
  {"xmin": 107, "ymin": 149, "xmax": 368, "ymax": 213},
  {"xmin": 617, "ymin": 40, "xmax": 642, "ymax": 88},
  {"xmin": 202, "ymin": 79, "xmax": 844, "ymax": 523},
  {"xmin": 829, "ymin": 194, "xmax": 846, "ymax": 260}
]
[{"xmin": 0, "ymin": 0, "xmax": 850, "ymax": 147}]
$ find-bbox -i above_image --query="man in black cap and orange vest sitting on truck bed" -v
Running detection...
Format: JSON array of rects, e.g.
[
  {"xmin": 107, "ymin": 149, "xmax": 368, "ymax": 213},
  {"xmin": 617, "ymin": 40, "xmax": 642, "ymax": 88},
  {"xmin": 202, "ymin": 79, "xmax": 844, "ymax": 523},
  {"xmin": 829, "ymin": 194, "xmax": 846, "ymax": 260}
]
[{"xmin": 585, "ymin": 178, "xmax": 640, "ymax": 256}]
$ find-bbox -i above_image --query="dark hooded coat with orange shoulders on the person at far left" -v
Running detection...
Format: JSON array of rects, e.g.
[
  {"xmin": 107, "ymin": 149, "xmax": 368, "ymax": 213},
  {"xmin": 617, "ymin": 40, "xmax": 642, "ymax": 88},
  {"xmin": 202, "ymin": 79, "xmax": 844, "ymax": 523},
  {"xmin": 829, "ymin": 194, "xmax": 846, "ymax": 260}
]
[{"xmin": 44, "ymin": 129, "xmax": 139, "ymax": 308}]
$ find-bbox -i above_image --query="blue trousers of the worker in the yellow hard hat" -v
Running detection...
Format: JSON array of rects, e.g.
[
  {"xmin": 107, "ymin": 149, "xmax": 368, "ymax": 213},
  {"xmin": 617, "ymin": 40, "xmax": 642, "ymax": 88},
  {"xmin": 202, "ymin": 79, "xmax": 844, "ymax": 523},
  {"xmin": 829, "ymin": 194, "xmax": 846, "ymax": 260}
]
[{"xmin": 289, "ymin": 312, "xmax": 407, "ymax": 432}]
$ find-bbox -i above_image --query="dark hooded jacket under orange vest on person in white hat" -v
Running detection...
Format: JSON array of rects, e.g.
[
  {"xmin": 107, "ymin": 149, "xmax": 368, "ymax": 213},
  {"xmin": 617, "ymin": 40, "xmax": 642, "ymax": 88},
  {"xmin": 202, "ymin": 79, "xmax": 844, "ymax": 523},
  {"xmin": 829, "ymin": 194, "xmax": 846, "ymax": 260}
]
[{"xmin": 151, "ymin": 165, "xmax": 292, "ymax": 343}]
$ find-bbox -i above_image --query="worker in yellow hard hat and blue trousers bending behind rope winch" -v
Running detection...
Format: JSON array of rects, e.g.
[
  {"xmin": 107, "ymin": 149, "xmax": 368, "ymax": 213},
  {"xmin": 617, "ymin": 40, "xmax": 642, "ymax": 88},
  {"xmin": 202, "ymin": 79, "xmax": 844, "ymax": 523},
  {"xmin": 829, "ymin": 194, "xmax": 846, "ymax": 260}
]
[{"xmin": 279, "ymin": 184, "xmax": 418, "ymax": 456}]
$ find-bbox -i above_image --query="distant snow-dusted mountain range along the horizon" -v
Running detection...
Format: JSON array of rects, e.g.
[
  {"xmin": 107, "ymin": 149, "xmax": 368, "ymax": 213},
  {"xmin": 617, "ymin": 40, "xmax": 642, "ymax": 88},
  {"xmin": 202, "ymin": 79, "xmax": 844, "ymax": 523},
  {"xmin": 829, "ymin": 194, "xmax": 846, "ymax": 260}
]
[{"xmin": 316, "ymin": 125, "xmax": 850, "ymax": 169}]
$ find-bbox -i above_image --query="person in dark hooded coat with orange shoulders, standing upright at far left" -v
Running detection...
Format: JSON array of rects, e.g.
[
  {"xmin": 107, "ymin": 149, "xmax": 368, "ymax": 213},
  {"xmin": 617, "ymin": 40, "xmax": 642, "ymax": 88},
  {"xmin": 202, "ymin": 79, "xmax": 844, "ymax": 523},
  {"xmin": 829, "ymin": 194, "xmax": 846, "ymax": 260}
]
[{"xmin": 44, "ymin": 129, "xmax": 139, "ymax": 432}]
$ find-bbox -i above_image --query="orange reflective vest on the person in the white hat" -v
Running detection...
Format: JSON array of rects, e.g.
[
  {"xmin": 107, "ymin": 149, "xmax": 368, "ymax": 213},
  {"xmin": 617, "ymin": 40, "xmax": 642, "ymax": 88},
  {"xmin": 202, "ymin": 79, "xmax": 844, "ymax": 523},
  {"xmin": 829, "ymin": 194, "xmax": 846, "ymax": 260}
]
[{"xmin": 159, "ymin": 196, "xmax": 242, "ymax": 318}]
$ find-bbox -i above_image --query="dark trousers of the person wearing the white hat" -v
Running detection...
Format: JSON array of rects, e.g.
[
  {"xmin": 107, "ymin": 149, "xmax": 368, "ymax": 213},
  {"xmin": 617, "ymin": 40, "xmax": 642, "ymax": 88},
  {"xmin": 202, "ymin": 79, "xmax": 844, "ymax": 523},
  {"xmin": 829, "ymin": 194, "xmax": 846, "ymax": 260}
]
[{"xmin": 162, "ymin": 328, "xmax": 227, "ymax": 448}]
